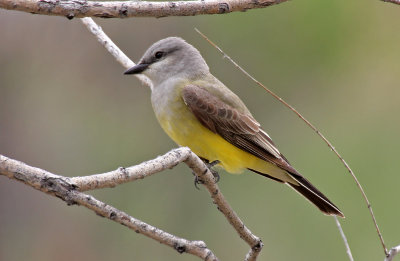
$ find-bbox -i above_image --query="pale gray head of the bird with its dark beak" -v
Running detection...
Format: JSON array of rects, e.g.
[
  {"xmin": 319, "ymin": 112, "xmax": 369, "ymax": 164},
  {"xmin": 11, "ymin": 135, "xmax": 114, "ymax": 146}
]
[{"xmin": 124, "ymin": 37, "xmax": 209, "ymax": 85}]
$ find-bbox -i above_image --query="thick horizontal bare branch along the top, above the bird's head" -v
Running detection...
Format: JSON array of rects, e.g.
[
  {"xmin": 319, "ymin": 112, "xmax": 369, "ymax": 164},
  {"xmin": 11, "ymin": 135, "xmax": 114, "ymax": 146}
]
[{"xmin": 0, "ymin": 0, "xmax": 287, "ymax": 19}]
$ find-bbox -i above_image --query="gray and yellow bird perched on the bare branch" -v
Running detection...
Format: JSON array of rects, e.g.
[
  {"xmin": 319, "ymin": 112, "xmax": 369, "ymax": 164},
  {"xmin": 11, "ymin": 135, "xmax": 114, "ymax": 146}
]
[{"xmin": 125, "ymin": 37, "xmax": 344, "ymax": 217}]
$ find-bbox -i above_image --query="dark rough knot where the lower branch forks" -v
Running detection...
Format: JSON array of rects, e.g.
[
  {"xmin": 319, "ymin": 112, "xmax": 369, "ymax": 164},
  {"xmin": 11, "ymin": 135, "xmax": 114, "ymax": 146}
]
[{"xmin": 40, "ymin": 177, "xmax": 77, "ymax": 206}]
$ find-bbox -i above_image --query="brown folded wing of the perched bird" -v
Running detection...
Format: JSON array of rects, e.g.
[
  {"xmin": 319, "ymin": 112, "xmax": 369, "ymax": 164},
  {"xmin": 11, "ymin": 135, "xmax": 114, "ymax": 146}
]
[{"xmin": 182, "ymin": 85, "xmax": 300, "ymax": 175}]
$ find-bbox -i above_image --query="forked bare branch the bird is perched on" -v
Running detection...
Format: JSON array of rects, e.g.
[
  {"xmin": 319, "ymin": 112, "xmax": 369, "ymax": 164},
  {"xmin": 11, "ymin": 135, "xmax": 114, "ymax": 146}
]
[{"xmin": 0, "ymin": 147, "xmax": 263, "ymax": 261}]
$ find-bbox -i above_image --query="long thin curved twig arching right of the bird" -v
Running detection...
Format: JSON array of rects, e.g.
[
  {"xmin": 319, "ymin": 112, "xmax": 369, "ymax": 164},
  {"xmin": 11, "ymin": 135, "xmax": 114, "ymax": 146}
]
[{"xmin": 195, "ymin": 28, "xmax": 388, "ymax": 256}]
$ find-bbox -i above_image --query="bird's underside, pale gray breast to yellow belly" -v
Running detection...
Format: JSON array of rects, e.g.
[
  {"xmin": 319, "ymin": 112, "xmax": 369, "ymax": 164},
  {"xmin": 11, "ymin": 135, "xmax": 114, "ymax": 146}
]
[{"xmin": 152, "ymin": 82, "xmax": 294, "ymax": 183}]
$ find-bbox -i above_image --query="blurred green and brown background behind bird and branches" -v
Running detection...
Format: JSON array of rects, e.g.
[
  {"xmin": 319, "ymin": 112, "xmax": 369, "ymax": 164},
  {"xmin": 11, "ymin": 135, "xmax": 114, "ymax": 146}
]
[{"xmin": 0, "ymin": 0, "xmax": 400, "ymax": 261}]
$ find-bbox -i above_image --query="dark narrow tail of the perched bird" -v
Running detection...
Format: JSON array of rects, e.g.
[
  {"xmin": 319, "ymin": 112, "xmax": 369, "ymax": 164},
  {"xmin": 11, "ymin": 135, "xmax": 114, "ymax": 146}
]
[{"xmin": 288, "ymin": 175, "xmax": 344, "ymax": 218}]
